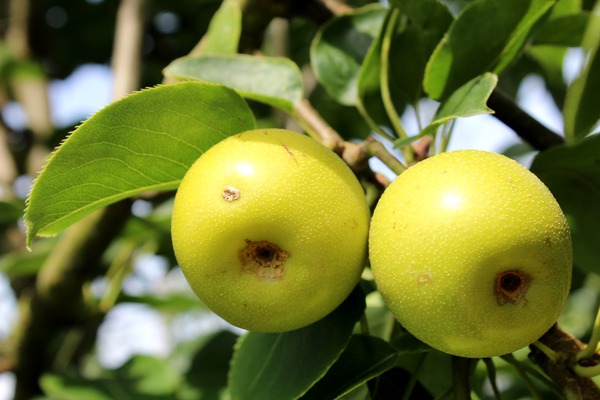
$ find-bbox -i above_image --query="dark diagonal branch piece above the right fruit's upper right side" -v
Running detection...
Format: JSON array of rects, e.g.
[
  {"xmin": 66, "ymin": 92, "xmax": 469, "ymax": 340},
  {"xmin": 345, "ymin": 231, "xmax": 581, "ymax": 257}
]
[{"xmin": 487, "ymin": 88, "xmax": 564, "ymax": 150}]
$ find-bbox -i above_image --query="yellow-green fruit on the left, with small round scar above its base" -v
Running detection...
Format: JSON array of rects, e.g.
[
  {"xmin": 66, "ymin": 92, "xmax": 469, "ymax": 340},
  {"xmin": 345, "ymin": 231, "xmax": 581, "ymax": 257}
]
[{"xmin": 172, "ymin": 129, "xmax": 370, "ymax": 332}]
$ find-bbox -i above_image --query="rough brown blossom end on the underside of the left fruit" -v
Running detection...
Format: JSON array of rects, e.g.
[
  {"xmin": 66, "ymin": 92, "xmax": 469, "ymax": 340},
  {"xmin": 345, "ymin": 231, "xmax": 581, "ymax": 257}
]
[{"xmin": 239, "ymin": 240, "xmax": 291, "ymax": 280}]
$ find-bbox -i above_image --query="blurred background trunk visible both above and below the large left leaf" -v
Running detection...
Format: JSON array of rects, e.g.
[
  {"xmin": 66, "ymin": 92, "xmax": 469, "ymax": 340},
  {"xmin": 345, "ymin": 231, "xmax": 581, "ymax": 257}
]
[{"xmin": 13, "ymin": 0, "xmax": 146, "ymax": 400}]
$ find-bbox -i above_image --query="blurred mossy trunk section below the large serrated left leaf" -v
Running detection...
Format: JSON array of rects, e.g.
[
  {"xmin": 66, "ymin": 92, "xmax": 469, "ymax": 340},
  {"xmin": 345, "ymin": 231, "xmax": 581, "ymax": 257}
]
[{"xmin": 14, "ymin": 201, "xmax": 131, "ymax": 400}]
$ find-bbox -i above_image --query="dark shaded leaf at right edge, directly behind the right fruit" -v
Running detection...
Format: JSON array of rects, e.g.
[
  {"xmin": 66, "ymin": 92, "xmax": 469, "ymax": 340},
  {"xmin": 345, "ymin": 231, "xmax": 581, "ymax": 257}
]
[{"xmin": 531, "ymin": 134, "xmax": 600, "ymax": 274}]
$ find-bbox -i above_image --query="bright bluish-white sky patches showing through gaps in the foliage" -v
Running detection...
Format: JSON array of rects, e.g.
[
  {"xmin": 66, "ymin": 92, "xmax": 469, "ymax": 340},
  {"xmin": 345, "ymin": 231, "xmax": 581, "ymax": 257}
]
[{"xmin": 0, "ymin": 45, "xmax": 582, "ymax": 400}]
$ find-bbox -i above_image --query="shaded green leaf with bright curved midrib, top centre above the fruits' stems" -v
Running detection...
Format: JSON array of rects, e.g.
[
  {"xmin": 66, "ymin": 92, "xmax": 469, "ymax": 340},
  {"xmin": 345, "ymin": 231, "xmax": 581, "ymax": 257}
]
[{"xmin": 357, "ymin": 0, "xmax": 452, "ymax": 138}]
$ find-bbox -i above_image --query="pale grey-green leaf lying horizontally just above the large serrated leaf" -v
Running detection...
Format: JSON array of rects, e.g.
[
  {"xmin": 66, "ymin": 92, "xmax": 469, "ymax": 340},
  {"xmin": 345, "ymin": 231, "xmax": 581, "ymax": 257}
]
[{"xmin": 164, "ymin": 54, "xmax": 303, "ymax": 112}]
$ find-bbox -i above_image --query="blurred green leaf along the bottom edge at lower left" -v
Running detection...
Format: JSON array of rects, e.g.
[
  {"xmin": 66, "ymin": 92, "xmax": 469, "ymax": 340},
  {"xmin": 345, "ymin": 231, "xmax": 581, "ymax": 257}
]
[{"xmin": 40, "ymin": 356, "xmax": 179, "ymax": 400}]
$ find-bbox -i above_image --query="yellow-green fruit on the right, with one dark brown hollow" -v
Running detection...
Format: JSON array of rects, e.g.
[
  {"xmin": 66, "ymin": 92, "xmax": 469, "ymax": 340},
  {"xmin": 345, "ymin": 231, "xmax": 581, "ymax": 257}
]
[{"xmin": 369, "ymin": 150, "xmax": 572, "ymax": 357}]
